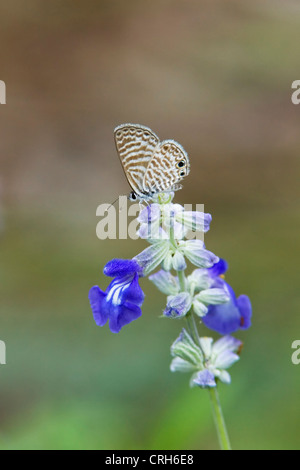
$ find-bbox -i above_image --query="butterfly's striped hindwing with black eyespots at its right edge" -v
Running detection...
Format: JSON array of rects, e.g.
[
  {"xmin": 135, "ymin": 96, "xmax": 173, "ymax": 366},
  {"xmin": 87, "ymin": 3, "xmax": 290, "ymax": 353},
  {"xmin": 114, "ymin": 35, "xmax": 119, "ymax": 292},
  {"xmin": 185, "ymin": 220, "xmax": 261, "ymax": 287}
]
[{"xmin": 143, "ymin": 140, "xmax": 190, "ymax": 194}]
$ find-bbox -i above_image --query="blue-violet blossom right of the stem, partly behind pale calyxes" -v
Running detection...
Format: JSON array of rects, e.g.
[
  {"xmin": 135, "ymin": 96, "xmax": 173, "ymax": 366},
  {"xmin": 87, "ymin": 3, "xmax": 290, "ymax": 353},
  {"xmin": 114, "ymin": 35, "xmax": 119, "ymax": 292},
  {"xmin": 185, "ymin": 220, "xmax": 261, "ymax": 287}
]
[{"xmin": 202, "ymin": 259, "xmax": 252, "ymax": 335}]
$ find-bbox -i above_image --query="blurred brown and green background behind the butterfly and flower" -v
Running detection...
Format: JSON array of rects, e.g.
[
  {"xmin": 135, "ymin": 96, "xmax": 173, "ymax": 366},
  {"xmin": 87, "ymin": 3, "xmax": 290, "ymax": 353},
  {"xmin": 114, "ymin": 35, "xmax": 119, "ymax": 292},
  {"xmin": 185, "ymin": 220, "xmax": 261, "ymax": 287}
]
[{"xmin": 0, "ymin": 0, "xmax": 300, "ymax": 449}]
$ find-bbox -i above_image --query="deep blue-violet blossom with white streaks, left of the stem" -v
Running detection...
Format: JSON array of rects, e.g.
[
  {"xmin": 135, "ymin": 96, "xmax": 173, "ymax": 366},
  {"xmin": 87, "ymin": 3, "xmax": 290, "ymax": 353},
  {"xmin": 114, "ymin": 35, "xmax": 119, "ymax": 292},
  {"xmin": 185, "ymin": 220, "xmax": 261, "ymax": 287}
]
[{"xmin": 89, "ymin": 259, "xmax": 144, "ymax": 333}]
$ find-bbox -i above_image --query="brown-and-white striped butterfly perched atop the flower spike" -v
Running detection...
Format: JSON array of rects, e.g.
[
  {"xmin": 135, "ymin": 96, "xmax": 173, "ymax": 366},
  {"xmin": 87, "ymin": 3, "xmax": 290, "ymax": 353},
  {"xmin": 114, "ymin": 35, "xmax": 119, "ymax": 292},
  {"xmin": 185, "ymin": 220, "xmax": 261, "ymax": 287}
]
[{"xmin": 114, "ymin": 124, "xmax": 190, "ymax": 201}]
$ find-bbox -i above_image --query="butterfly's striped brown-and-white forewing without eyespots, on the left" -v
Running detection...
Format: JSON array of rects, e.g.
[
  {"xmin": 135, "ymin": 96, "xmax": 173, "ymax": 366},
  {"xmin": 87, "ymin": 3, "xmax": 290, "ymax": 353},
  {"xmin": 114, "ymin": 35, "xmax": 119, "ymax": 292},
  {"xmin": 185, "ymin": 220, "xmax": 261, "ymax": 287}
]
[{"xmin": 114, "ymin": 124, "xmax": 159, "ymax": 196}]
